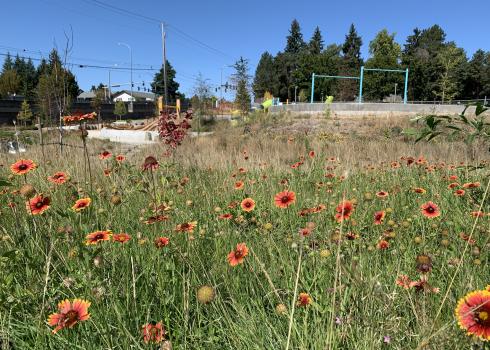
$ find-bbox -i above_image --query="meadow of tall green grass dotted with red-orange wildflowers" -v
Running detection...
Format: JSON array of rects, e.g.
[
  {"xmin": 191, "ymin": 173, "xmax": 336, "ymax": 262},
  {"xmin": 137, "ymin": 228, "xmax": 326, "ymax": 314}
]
[{"xmin": 0, "ymin": 116, "xmax": 490, "ymax": 349}]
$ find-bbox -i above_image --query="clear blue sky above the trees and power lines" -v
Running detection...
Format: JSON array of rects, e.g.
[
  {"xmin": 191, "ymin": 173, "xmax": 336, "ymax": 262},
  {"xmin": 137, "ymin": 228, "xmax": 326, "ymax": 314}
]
[{"xmin": 0, "ymin": 0, "xmax": 490, "ymax": 97}]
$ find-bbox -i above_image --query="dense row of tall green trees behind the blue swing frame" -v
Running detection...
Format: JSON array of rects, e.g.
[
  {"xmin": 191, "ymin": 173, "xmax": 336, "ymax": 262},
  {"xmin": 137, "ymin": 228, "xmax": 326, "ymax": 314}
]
[{"xmin": 253, "ymin": 19, "xmax": 490, "ymax": 101}]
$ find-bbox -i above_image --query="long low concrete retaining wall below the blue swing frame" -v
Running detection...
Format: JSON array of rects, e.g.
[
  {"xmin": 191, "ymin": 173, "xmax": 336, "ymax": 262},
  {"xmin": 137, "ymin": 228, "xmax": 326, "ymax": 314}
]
[{"xmin": 269, "ymin": 103, "xmax": 486, "ymax": 117}]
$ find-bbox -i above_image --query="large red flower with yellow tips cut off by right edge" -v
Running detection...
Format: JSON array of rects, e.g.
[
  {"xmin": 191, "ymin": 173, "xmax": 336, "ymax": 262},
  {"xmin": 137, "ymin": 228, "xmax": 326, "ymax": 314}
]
[{"xmin": 455, "ymin": 290, "xmax": 490, "ymax": 340}]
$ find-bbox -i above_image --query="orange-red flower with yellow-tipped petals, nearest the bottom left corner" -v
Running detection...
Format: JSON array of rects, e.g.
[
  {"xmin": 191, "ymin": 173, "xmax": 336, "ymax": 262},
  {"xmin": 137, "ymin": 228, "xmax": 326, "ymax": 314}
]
[{"xmin": 48, "ymin": 299, "xmax": 90, "ymax": 333}]
